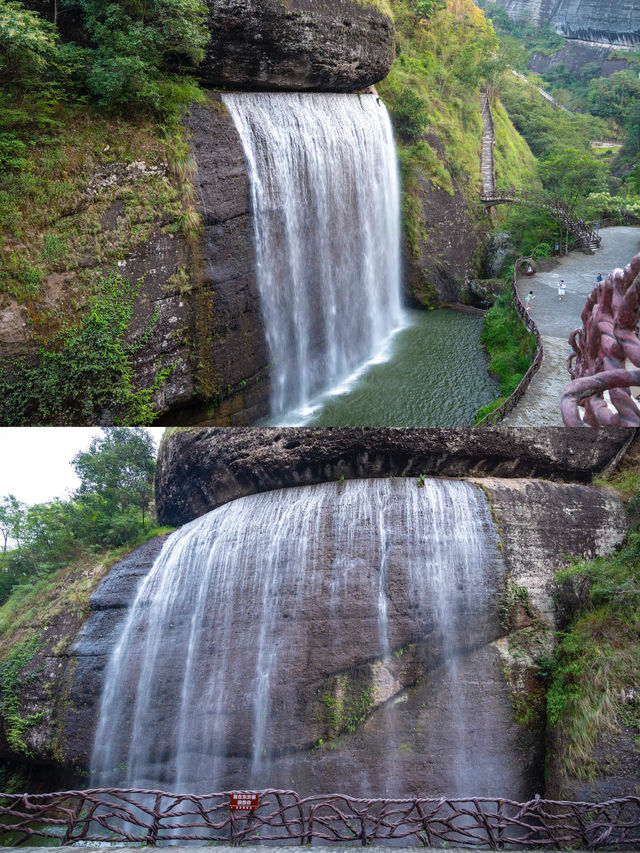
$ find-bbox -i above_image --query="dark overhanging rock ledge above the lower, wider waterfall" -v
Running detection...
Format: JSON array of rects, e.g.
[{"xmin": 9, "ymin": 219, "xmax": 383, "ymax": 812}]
[{"xmin": 156, "ymin": 427, "xmax": 634, "ymax": 526}]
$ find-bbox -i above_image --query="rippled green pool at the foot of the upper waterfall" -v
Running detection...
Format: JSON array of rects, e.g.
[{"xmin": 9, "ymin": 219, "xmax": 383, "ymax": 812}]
[{"xmin": 270, "ymin": 308, "xmax": 500, "ymax": 427}]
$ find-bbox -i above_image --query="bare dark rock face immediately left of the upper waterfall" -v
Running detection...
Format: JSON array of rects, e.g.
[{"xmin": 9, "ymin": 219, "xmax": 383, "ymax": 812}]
[{"xmin": 120, "ymin": 99, "xmax": 269, "ymax": 425}]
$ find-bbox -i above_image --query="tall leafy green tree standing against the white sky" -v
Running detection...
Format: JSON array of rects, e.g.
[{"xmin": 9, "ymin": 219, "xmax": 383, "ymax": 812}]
[{"xmin": 72, "ymin": 427, "xmax": 156, "ymax": 528}]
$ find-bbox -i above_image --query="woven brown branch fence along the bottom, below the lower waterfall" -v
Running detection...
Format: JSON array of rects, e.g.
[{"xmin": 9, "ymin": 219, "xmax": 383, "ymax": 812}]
[{"xmin": 0, "ymin": 788, "xmax": 640, "ymax": 850}]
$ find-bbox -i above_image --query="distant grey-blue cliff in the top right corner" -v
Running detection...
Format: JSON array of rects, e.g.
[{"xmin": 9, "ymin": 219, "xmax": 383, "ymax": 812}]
[{"xmin": 488, "ymin": 0, "xmax": 640, "ymax": 47}]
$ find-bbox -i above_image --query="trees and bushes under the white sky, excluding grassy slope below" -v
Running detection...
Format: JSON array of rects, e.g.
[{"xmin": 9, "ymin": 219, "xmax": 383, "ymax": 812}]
[{"xmin": 0, "ymin": 427, "xmax": 160, "ymax": 604}]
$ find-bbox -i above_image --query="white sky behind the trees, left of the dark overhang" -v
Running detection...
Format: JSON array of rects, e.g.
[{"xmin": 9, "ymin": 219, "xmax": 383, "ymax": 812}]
[{"xmin": 0, "ymin": 427, "xmax": 164, "ymax": 504}]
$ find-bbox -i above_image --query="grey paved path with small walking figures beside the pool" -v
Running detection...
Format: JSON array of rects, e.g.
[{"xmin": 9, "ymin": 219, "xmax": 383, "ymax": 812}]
[{"xmin": 502, "ymin": 225, "xmax": 640, "ymax": 427}]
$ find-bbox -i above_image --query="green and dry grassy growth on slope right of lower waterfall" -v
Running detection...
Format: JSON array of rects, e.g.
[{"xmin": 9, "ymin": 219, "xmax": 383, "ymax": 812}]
[{"xmin": 547, "ymin": 453, "xmax": 640, "ymax": 779}]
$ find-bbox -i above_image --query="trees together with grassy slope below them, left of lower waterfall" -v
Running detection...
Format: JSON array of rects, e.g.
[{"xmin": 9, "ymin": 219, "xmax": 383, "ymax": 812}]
[{"xmin": 0, "ymin": 428, "xmax": 174, "ymax": 772}]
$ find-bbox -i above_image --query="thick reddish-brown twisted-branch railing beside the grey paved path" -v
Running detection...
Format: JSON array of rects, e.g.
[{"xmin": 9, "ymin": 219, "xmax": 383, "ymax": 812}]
[{"xmin": 561, "ymin": 255, "xmax": 640, "ymax": 427}]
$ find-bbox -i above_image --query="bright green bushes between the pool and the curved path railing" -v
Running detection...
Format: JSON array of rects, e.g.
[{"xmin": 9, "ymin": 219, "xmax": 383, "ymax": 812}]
[{"xmin": 476, "ymin": 293, "xmax": 536, "ymax": 421}]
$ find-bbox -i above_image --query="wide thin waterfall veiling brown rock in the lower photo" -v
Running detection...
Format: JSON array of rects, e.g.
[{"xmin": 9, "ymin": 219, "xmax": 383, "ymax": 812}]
[{"xmin": 92, "ymin": 479, "xmax": 509, "ymax": 796}]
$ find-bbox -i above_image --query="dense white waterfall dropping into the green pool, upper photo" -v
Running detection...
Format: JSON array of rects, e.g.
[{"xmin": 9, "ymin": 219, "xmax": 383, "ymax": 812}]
[{"xmin": 223, "ymin": 94, "xmax": 404, "ymax": 425}]
